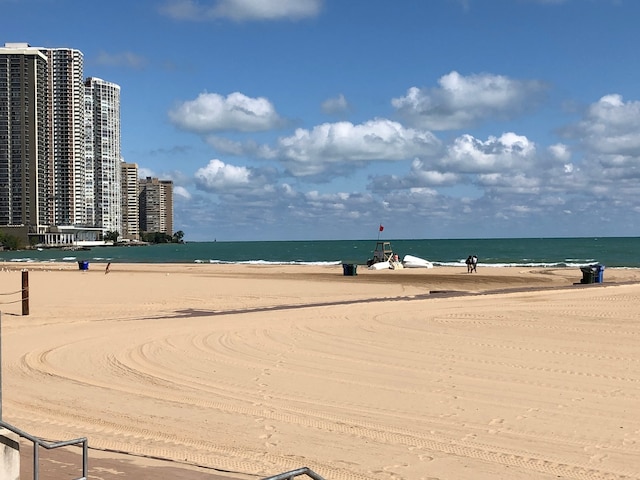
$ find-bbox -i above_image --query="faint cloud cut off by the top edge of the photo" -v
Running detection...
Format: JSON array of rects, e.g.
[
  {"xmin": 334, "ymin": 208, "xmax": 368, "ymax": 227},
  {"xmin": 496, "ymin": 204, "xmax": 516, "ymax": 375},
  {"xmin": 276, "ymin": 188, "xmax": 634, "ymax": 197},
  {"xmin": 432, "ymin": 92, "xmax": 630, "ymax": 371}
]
[{"xmin": 160, "ymin": 0, "xmax": 323, "ymax": 21}]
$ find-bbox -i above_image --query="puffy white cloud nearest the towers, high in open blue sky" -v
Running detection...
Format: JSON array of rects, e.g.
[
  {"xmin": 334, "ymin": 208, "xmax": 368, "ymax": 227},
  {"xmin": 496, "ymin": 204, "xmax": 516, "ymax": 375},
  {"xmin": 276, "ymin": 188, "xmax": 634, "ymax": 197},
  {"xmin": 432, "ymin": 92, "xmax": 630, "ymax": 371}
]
[{"xmin": 169, "ymin": 92, "xmax": 282, "ymax": 133}]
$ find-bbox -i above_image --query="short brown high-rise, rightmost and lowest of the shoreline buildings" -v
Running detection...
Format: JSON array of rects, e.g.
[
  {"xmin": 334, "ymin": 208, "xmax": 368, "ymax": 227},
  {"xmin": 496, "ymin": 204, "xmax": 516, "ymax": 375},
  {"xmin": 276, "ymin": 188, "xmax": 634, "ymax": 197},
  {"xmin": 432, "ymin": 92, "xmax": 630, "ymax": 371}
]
[{"xmin": 140, "ymin": 177, "xmax": 173, "ymax": 235}]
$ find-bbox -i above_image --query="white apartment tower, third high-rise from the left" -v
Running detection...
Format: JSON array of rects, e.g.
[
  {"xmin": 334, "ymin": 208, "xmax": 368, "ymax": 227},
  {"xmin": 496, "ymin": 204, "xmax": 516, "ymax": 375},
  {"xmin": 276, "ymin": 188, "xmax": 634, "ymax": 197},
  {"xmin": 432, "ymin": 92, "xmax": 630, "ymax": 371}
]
[{"xmin": 83, "ymin": 77, "xmax": 122, "ymax": 234}]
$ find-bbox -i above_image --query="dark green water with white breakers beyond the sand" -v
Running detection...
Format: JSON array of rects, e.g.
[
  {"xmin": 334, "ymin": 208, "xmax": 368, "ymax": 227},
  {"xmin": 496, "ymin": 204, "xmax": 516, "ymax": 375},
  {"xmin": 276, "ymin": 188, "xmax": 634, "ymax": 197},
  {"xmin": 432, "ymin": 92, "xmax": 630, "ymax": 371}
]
[{"xmin": 0, "ymin": 237, "xmax": 640, "ymax": 268}]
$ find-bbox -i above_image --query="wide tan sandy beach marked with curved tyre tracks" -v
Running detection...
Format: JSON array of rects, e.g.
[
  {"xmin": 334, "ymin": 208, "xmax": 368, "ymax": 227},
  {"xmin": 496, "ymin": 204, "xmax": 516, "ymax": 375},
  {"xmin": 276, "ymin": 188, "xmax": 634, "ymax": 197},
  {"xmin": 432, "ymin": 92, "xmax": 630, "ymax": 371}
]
[{"xmin": 0, "ymin": 263, "xmax": 640, "ymax": 480}]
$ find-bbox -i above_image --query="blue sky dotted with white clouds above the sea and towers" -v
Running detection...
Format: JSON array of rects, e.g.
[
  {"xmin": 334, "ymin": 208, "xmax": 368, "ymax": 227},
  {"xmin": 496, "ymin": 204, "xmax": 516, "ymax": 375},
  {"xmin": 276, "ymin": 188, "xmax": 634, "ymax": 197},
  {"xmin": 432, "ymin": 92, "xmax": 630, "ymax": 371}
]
[{"xmin": 0, "ymin": 0, "xmax": 640, "ymax": 241}]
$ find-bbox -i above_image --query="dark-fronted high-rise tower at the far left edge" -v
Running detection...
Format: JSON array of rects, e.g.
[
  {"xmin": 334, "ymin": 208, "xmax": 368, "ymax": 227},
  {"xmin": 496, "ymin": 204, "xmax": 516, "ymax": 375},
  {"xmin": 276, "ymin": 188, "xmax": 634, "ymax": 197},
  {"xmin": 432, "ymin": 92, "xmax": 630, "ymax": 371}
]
[{"xmin": 0, "ymin": 43, "xmax": 52, "ymax": 234}]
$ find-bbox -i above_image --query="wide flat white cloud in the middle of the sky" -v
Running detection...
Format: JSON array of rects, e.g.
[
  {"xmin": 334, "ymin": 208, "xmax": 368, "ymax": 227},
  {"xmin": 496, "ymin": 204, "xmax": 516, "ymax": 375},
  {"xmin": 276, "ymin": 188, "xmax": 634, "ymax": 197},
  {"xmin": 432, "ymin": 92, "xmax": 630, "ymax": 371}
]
[{"xmin": 267, "ymin": 119, "xmax": 440, "ymax": 177}]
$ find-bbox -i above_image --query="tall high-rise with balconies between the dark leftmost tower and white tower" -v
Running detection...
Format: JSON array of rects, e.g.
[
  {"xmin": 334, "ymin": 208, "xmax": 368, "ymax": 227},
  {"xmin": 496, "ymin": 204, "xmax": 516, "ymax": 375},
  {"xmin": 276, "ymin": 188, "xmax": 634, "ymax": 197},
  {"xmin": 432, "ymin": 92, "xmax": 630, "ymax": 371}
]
[{"xmin": 40, "ymin": 48, "xmax": 85, "ymax": 226}]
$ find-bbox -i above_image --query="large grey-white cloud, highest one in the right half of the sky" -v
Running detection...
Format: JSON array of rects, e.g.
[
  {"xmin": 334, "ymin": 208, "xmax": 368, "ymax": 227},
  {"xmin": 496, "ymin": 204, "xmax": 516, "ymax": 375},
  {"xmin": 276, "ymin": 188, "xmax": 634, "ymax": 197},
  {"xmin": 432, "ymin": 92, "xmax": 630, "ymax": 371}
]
[{"xmin": 391, "ymin": 71, "xmax": 545, "ymax": 130}]
